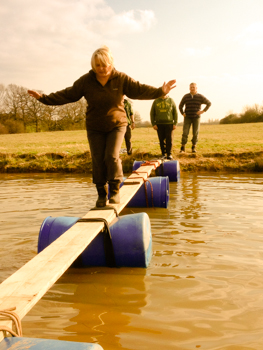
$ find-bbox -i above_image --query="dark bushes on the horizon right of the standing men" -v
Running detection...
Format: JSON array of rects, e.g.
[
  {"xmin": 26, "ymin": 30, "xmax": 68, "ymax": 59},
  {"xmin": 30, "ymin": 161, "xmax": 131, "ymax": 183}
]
[{"xmin": 220, "ymin": 104, "xmax": 263, "ymax": 124}]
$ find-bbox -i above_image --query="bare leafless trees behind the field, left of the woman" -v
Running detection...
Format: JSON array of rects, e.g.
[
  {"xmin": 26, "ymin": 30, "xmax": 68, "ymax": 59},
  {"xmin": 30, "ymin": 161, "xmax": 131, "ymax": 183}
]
[{"xmin": 0, "ymin": 84, "xmax": 87, "ymax": 134}]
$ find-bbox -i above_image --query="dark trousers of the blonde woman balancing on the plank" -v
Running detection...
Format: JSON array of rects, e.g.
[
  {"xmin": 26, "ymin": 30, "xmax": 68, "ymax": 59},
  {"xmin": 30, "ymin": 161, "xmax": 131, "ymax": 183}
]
[{"xmin": 87, "ymin": 126, "xmax": 126, "ymax": 184}]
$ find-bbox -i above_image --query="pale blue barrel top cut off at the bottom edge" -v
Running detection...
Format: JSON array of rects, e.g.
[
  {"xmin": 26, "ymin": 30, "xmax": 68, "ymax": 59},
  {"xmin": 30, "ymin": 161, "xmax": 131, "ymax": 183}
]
[{"xmin": 0, "ymin": 337, "xmax": 103, "ymax": 350}]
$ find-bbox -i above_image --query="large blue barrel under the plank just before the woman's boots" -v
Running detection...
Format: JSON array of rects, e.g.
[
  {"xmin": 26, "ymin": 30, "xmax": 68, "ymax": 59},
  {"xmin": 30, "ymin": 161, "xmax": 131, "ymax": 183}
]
[{"xmin": 38, "ymin": 213, "xmax": 152, "ymax": 267}]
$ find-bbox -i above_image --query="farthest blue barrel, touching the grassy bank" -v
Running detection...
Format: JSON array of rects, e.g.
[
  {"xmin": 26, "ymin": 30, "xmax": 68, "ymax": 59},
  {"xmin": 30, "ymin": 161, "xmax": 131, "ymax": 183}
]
[{"xmin": 132, "ymin": 160, "xmax": 180, "ymax": 182}]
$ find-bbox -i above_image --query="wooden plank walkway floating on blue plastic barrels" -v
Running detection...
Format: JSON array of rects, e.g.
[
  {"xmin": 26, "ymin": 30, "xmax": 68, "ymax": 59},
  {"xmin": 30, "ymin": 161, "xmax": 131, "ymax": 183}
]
[{"xmin": 0, "ymin": 160, "xmax": 180, "ymax": 350}]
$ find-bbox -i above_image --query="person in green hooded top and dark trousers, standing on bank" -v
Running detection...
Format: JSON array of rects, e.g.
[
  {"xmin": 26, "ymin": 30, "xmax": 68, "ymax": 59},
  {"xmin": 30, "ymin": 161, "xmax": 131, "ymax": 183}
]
[{"xmin": 150, "ymin": 95, "xmax": 177, "ymax": 160}]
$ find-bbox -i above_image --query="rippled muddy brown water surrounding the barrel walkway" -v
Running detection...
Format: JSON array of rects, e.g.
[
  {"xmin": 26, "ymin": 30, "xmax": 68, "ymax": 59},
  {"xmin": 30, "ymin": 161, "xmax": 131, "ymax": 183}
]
[{"xmin": 0, "ymin": 174, "xmax": 263, "ymax": 350}]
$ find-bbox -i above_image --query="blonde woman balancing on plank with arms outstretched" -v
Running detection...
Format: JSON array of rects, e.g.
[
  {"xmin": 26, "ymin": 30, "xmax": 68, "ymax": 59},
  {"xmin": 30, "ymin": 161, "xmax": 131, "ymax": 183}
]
[{"xmin": 28, "ymin": 46, "xmax": 176, "ymax": 207}]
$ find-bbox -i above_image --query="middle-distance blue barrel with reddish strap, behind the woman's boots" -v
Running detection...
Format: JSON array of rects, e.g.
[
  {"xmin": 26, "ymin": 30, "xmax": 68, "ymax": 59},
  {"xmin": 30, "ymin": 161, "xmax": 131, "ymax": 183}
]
[{"xmin": 120, "ymin": 176, "xmax": 170, "ymax": 208}]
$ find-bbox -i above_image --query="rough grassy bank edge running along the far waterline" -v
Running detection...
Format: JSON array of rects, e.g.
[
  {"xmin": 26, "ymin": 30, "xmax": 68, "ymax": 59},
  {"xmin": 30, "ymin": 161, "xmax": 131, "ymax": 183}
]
[{"xmin": 0, "ymin": 151, "xmax": 263, "ymax": 174}]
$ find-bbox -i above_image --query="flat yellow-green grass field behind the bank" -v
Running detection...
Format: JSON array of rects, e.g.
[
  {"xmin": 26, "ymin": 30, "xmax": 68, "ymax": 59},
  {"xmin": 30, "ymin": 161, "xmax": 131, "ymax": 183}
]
[{"xmin": 0, "ymin": 123, "xmax": 263, "ymax": 155}]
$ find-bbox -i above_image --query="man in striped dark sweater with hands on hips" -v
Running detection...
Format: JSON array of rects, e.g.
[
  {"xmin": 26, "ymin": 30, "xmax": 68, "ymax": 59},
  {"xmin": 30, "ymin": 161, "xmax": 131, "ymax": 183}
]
[{"xmin": 179, "ymin": 83, "xmax": 211, "ymax": 153}]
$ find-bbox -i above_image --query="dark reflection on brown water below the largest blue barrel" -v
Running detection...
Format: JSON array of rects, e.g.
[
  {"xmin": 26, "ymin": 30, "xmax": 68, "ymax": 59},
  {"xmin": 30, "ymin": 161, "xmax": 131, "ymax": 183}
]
[{"xmin": 63, "ymin": 268, "xmax": 146, "ymax": 348}]
